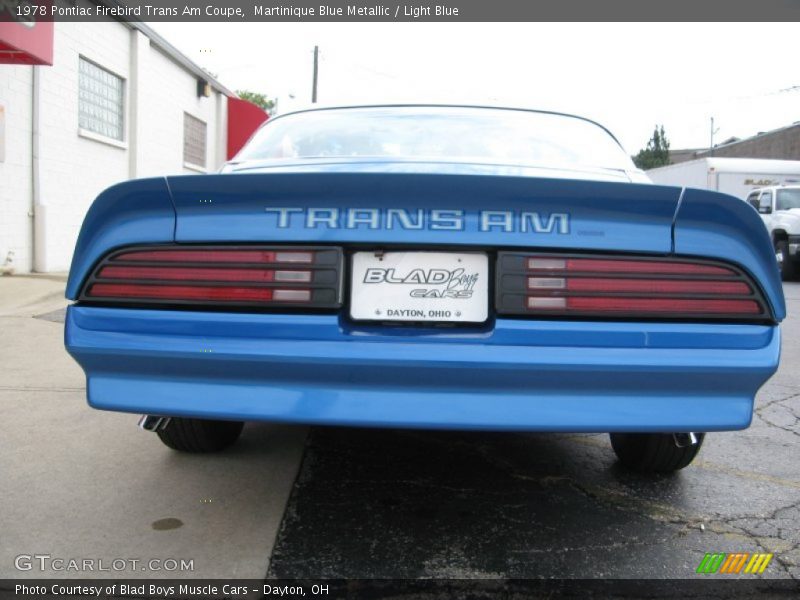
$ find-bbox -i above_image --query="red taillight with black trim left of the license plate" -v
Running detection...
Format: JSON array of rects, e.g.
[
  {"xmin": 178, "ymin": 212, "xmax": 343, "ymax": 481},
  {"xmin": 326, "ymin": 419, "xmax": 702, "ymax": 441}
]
[{"xmin": 81, "ymin": 246, "xmax": 343, "ymax": 308}]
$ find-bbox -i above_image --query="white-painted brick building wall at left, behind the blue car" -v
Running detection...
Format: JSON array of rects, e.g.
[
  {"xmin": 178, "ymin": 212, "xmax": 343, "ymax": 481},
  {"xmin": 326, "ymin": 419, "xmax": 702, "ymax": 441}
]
[{"xmin": 0, "ymin": 16, "xmax": 226, "ymax": 272}]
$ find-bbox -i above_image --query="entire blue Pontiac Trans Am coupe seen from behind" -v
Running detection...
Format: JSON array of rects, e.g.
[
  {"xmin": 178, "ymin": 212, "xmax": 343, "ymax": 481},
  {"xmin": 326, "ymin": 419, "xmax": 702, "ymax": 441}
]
[{"xmin": 66, "ymin": 106, "xmax": 785, "ymax": 471}]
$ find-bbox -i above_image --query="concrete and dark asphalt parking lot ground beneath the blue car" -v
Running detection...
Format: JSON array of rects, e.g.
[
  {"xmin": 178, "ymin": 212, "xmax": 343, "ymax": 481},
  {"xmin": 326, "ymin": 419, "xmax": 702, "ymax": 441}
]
[{"xmin": 0, "ymin": 276, "xmax": 800, "ymax": 578}]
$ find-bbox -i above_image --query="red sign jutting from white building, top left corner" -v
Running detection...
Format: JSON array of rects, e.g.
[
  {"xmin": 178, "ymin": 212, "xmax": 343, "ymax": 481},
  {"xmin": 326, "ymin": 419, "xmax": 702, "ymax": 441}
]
[{"xmin": 0, "ymin": 2, "xmax": 53, "ymax": 65}]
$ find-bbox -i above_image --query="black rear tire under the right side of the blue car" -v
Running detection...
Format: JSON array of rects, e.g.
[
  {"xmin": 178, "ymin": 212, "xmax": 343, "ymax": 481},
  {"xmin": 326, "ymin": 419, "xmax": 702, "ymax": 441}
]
[{"xmin": 609, "ymin": 433, "xmax": 705, "ymax": 473}]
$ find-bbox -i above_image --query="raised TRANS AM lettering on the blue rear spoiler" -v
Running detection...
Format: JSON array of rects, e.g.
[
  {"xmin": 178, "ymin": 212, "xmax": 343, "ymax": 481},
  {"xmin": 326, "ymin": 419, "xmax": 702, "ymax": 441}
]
[{"xmin": 265, "ymin": 206, "xmax": 570, "ymax": 234}]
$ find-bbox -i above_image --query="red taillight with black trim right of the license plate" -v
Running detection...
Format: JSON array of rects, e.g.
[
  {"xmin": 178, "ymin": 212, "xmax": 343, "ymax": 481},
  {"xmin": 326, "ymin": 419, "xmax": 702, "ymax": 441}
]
[{"xmin": 496, "ymin": 252, "xmax": 769, "ymax": 320}]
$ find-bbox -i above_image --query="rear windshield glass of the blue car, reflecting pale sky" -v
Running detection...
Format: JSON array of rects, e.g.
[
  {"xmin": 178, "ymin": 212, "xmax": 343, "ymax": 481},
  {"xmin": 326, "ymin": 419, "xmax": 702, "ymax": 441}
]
[{"xmin": 235, "ymin": 107, "xmax": 634, "ymax": 170}]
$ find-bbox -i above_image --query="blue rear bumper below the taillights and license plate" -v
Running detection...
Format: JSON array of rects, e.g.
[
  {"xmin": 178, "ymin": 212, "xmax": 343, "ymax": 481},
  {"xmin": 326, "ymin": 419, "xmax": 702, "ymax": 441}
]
[{"xmin": 65, "ymin": 306, "xmax": 780, "ymax": 432}]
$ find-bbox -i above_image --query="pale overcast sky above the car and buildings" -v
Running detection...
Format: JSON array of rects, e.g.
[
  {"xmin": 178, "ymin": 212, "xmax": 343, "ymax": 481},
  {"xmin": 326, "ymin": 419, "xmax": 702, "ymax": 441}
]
[{"xmin": 149, "ymin": 23, "xmax": 800, "ymax": 154}]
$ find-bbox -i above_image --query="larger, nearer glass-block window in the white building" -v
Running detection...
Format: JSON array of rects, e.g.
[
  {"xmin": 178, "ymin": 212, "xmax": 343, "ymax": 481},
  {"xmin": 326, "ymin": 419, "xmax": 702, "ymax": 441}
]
[{"xmin": 78, "ymin": 57, "xmax": 125, "ymax": 142}]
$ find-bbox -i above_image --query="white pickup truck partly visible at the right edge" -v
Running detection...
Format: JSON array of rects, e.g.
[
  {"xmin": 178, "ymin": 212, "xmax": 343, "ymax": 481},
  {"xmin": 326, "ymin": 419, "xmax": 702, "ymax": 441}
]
[{"xmin": 747, "ymin": 185, "xmax": 800, "ymax": 280}]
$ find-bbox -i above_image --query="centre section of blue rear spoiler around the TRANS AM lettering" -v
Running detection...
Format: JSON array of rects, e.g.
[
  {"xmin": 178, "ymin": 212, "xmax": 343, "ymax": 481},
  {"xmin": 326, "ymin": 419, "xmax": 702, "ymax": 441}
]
[{"xmin": 170, "ymin": 173, "xmax": 680, "ymax": 254}]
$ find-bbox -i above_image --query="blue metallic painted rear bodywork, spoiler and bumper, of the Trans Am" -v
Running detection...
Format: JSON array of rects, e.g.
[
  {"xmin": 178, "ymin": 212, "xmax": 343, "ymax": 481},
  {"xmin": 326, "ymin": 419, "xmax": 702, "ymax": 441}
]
[{"xmin": 66, "ymin": 167, "xmax": 785, "ymax": 431}]
